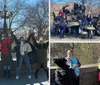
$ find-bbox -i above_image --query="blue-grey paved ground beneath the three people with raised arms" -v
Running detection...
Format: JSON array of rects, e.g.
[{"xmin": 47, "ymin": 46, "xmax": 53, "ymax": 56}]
[{"xmin": 0, "ymin": 70, "xmax": 49, "ymax": 85}]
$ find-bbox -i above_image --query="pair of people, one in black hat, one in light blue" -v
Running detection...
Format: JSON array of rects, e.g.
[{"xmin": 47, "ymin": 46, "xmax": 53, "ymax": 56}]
[{"xmin": 54, "ymin": 49, "xmax": 81, "ymax": 85}]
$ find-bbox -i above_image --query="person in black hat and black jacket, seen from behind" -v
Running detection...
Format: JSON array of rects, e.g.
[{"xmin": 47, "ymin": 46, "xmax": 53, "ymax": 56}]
[{"xmin": 55, "ymin": 59, "xmax": 76, "ymax": 85}]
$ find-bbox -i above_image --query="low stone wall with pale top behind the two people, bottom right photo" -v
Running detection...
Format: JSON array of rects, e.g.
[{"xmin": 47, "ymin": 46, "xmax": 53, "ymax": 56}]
[{"xmin": 50, "ymin": 64, "xmax": 98, "ymax": 85}]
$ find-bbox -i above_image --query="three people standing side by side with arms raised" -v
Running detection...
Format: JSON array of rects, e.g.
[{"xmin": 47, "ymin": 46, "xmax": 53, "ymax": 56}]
[{"xmin": 0, "ymin": 33, "xmax": 49, "ymax": 79}]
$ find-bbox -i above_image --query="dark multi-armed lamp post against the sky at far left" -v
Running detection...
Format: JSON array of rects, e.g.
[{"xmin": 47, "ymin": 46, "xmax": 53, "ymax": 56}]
[{"xmin": 0, "ymin": 0, "xmax": 13, "ymax": 34}]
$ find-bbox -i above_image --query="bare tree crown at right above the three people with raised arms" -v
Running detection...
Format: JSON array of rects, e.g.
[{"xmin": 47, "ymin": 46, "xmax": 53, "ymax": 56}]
[{"xmin": 25, "ymin": 0, "xmax": 49, "ymax": 36}]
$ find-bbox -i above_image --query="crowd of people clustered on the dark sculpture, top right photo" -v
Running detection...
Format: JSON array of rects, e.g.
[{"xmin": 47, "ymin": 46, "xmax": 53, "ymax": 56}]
[{"xmin": 53, "ymin": 3, "xmax": 100, "ymax": 38}]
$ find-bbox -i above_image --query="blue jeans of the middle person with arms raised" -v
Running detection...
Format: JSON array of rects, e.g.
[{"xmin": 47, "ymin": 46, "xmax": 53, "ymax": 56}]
[{"xmin": 16, "ymin": 54, "xmax": 31, "ymax": 76}]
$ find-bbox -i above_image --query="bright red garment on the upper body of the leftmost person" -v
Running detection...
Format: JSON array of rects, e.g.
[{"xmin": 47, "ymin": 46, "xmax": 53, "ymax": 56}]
[{"xmin": 1, "ymin": 38, "xmax": 12, "ymax": 56}]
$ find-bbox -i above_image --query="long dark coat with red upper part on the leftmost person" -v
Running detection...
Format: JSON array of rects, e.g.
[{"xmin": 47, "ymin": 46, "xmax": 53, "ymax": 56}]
[{"xmin": 1, "ymin": 38, "xmax": 12, "ymax": 65}]
